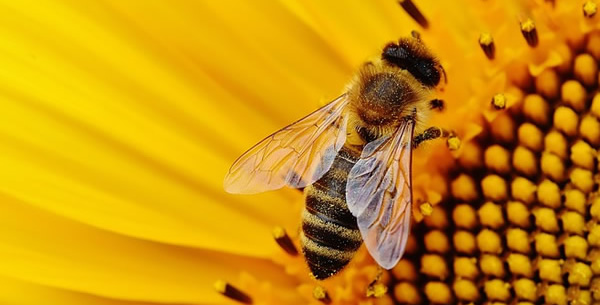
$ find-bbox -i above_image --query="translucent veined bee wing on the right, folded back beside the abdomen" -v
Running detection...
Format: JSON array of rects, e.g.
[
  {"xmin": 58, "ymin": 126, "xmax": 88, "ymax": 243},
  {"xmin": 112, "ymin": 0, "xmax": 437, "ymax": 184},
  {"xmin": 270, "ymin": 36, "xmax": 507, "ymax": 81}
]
[{"xmin": 346, "ymin": 120, "xmax": 414, "ymax": 269}]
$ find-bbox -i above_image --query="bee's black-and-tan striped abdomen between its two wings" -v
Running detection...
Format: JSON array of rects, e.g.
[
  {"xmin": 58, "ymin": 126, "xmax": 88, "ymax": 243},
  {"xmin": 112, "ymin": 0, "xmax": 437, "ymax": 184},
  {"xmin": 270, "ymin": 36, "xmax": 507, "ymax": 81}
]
[{"xmin": 300, "ymin": 146, "xmax": 362, "ymax": 280}]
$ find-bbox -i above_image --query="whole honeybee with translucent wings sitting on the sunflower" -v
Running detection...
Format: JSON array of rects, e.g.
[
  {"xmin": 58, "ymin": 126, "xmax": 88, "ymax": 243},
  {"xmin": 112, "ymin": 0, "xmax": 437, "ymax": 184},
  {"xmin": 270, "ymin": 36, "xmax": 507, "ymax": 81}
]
[{"xmin": 224, "ymin": 35, "xmax": 448, "ymax": 280}]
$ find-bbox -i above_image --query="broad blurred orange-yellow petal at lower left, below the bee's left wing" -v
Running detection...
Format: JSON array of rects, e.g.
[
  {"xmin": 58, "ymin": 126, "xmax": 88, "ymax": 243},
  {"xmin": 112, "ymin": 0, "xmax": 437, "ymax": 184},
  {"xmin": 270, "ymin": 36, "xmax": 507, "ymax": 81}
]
[{"xmin": 0, "ymin": 195, "xmax": 291, "ymax": 303}]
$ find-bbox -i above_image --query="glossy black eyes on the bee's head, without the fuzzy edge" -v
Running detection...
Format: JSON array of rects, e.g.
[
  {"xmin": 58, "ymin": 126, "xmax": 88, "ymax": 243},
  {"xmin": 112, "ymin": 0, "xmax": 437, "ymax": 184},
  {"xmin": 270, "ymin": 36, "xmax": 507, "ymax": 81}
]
[{"xmin": 381, "ymin": 44, "xmax": 441, "ymax": 88}]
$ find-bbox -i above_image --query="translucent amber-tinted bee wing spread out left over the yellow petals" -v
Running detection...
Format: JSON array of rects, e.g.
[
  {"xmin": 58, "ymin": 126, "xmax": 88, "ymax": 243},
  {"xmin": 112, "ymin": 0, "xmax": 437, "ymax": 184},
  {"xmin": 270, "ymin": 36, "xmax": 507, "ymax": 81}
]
[{"xmin": 224, "ymin": 94, "xmax": 348, "ymax": 194}]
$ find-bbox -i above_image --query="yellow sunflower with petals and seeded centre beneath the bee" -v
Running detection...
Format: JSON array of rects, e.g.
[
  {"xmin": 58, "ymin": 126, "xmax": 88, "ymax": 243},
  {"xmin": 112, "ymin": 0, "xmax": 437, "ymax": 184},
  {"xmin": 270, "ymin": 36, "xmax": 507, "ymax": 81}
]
[{"xmin": 0, "ymin": 0, "xmax": 600, "ymax": 305}]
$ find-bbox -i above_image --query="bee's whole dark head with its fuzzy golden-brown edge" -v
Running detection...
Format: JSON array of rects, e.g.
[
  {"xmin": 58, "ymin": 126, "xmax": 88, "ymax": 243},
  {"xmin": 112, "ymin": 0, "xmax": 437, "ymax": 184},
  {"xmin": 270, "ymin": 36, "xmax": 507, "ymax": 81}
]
[{"xmin": 381, "ymin": 36, "xmax": 447, "ymax": 88}]
